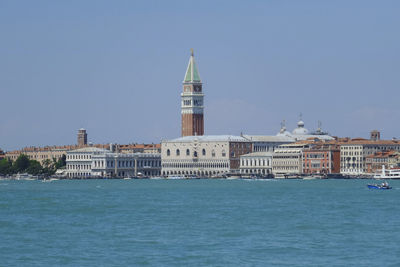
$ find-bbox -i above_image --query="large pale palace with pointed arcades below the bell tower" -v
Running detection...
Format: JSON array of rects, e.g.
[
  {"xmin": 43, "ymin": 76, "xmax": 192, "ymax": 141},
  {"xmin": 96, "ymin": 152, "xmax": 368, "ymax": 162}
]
[{"xmin": 161, "ymin": 135, "xmax": 252, "ymax": 177}]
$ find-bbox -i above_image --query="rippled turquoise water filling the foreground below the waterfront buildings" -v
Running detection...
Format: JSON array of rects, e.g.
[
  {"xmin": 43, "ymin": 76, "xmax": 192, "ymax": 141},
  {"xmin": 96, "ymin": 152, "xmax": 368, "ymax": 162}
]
[{"xmin": 0, "ymin": 180, "xmax": 400, "ymax": 266}]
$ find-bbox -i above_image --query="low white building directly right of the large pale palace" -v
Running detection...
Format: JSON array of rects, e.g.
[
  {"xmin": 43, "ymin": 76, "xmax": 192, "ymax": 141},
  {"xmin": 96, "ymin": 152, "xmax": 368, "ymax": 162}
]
[{"xmin": 239, "ymin": 152, "xmax": 272, "ymax": 176}]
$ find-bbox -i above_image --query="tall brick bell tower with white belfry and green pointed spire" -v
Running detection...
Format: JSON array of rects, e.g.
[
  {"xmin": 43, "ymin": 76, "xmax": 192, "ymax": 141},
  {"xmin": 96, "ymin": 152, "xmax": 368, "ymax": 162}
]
[{"xmin": 181, "ymin": 49, "xmax": 204, "ymax": 136}]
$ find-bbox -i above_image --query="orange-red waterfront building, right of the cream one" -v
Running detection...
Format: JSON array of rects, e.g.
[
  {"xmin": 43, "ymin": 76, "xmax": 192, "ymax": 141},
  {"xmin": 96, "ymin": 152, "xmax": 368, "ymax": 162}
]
[{"xmin": 303, "ymin": 146, "xmax": 340, "ymax": 174}]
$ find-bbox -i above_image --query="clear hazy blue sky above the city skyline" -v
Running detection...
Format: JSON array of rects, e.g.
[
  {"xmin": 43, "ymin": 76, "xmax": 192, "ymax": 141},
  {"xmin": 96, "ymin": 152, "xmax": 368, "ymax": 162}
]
[{"xmin": 0, "ymin": 0, "xmax": 400, "ymax": 151}]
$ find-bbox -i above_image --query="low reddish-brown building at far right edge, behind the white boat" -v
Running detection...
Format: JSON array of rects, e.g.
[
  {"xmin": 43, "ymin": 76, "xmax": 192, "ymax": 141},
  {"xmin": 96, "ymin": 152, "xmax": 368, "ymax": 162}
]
[{"xmin": 365, "ymin": 150, "xmax": 400, "ymax": 173}]
